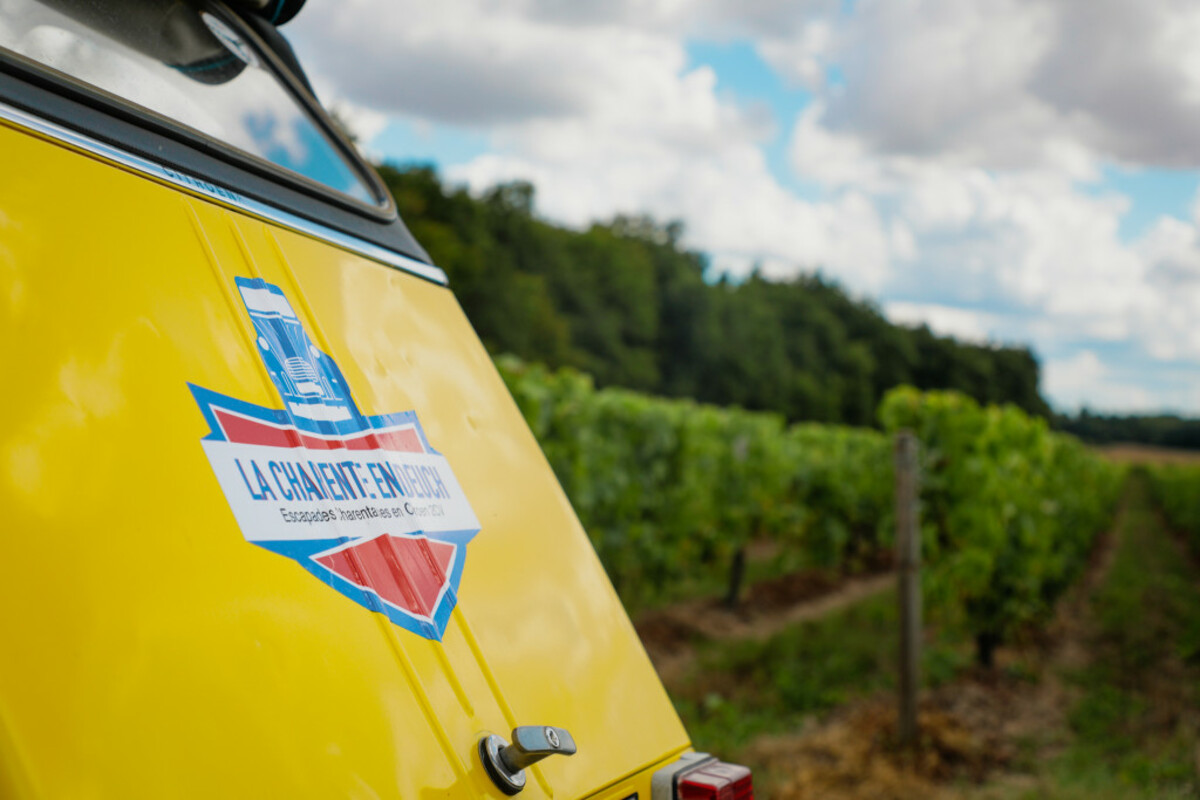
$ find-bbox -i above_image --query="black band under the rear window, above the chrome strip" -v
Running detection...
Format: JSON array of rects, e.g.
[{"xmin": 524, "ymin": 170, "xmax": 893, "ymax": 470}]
[{"xmin": 0, "ymin": 20, "xmax": 432, "ymax": 264}]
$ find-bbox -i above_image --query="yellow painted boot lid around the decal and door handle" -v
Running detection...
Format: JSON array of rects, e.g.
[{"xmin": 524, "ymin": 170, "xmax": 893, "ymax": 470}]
[{"xmin": 0, "ymin": 115, "xmax": 688, "ymax": 800}]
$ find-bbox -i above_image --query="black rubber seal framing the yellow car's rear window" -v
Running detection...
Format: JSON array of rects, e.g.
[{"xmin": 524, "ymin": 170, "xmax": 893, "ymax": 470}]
[{"xmin": 0, "ymin": 0, "xmax": 398, "ymax": 222}]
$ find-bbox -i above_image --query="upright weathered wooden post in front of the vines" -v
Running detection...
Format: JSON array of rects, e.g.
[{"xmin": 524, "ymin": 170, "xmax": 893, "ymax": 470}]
[{"xmin": 895, "ymin": 431, "xmax": 922, "ymax": 747}]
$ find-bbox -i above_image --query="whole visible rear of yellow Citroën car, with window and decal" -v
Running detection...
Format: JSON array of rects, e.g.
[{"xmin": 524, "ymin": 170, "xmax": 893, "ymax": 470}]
[{"xmin": 0, "ymin": 0, "xmax": 752, "ymax": 800}]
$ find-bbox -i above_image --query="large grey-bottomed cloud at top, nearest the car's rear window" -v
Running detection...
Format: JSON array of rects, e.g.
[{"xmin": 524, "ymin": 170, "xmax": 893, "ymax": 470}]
[{"xmin": 287, "ymin": 0, "xmax": 836, "ymax": 126}]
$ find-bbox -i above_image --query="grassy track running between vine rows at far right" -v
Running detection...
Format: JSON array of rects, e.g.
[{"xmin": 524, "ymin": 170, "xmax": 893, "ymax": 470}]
[{"xmin": 1022, "ymin": 475, "xmax": 1200, "ymax": 798}]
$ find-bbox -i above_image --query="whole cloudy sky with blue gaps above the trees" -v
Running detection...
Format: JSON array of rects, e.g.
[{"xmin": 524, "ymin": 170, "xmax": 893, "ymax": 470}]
[{"xmin": 284, "ymin": 0, "xmax": 1200, "ymax": 414}]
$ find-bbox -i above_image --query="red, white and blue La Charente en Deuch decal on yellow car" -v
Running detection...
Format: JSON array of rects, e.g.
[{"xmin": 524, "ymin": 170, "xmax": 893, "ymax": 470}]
[{"xmin": 188, "ymin": 278, "xmax": 479, "ymax": 640}]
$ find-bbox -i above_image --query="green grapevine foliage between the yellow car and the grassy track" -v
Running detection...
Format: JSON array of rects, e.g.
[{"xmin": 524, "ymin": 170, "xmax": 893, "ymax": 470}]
[{"xmin": 498, "ymin": 357, "xmax": 1121, "ymax": 660}]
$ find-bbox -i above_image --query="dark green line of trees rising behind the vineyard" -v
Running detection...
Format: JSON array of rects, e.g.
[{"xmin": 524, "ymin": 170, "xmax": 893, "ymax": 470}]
[{"xmin": 380, "ymin": 166, "xmax": 1049, "ymax": 425}]
